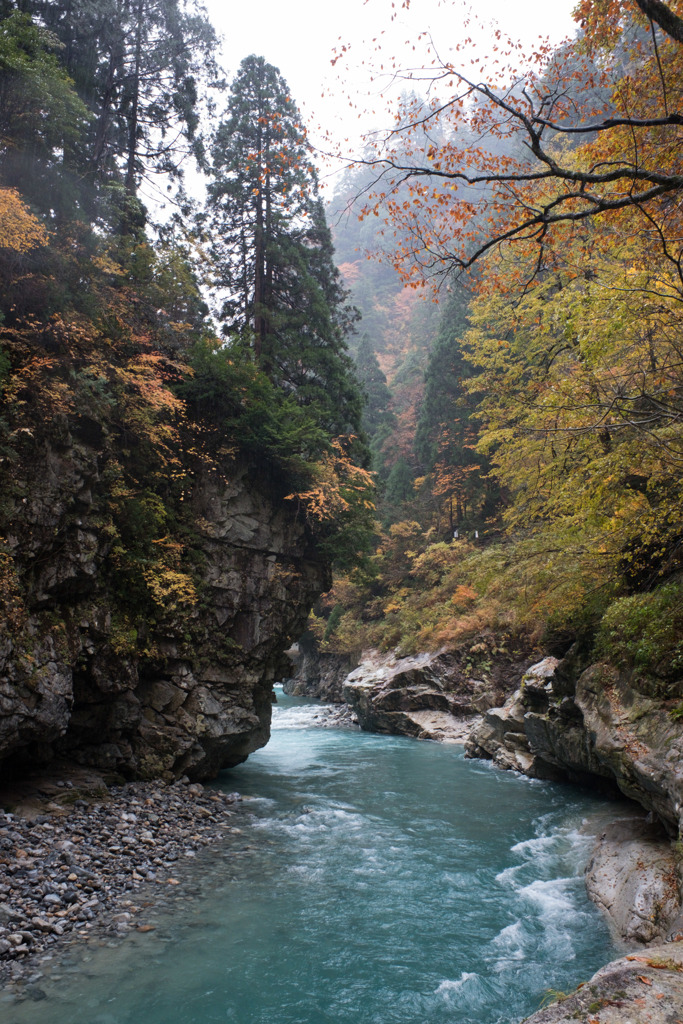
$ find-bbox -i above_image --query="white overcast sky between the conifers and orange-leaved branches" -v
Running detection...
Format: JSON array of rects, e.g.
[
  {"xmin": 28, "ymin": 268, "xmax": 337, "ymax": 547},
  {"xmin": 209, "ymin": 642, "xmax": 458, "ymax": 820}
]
[{"xmin": 204, "ymin": 0, "xmax": 575, "ymax": 171}]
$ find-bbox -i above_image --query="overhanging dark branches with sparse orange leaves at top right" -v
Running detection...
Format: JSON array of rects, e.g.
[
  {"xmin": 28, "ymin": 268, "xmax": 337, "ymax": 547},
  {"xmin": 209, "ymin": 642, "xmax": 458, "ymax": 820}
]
[{"xmin": 356, "ymin": 0, "xmax": 683, "ymax": 288}]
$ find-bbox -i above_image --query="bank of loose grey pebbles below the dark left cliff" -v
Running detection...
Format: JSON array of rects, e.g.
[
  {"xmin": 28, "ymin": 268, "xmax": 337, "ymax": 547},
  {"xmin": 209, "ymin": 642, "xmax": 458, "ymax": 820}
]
[{"xmin": 0, "ymin": 779, "xmax": 242, "ymax": 987}]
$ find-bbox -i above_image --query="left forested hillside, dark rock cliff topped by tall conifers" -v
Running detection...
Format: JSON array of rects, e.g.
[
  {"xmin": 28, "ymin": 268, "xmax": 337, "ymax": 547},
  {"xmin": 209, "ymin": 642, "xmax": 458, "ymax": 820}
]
[{"xmin": 0, "ymin": 0, "xmax": 373, "ymax": 775}]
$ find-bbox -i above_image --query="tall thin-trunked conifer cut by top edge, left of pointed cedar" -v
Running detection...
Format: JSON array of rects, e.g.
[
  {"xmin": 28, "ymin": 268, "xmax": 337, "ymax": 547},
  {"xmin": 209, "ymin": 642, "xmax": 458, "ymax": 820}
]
[{"xmin": 15, "ymin": 0, "xmax": 218, "ymax": 226}]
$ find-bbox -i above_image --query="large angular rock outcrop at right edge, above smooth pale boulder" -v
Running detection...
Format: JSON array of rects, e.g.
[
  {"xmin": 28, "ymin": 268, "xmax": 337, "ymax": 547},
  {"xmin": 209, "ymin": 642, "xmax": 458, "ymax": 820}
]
[{"xmin": 466, "ymin": 653, "xmax": 683, "ymax": 836}]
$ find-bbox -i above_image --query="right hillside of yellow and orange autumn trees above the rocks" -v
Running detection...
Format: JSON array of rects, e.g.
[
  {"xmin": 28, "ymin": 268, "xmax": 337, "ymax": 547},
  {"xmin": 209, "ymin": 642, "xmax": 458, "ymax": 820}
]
[{"xmin": 311, "ymin": 0, "xmax": 683, "ymax": 706}]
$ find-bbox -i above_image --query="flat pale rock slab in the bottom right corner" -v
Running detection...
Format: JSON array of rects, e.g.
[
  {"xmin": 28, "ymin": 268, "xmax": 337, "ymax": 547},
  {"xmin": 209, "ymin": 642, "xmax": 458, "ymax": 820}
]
[{"xmin": 523, "ymin": 942, "xmax": 683, "ymax": 1024}]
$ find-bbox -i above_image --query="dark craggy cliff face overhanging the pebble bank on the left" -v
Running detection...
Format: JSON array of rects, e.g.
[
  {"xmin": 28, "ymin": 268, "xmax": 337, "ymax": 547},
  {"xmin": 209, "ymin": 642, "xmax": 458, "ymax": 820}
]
[{"xmin": 0, "ymin": 417, "xmax": 328, "ymax": 778}]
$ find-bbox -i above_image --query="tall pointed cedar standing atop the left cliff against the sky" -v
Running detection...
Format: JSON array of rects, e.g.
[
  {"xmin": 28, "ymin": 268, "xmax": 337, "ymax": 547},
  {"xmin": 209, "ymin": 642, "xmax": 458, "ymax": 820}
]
[{"xmin": 208, "ymin": 55, "xmax": 361, "ymax": 434}]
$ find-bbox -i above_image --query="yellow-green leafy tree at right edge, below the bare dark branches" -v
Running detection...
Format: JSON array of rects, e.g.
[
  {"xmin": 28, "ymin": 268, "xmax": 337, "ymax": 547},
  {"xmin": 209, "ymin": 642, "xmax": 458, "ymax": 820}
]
[{"xmin": 468, "ymin": 223, "xmax": 683, "ymax": 592}]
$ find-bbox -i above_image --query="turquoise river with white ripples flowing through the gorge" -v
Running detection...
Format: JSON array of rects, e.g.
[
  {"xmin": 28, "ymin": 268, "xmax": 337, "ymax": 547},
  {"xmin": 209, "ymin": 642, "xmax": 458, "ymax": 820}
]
[{"xmin": 3, "ymin": 694, "xmax": 618, "ymax": 1024}]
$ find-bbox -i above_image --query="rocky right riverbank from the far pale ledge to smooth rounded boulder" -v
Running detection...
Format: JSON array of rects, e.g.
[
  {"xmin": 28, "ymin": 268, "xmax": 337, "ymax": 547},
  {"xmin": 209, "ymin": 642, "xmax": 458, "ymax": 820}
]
[{"xmin": 290, "ymin": 649, "xmax": 683, "ymax": 946}]
